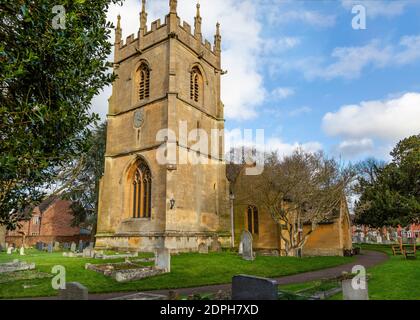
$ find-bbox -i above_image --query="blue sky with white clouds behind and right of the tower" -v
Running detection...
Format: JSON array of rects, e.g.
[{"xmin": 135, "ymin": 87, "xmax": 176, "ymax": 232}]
[{"xmin": 94, "ymin": 0, "xmax": 420, "ymax": 161}]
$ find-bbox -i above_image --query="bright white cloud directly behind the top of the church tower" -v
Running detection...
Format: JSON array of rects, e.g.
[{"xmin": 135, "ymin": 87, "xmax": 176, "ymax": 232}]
[{"xmin": 93, "ymin": 0, "xmax": 267, "ymax": 120}]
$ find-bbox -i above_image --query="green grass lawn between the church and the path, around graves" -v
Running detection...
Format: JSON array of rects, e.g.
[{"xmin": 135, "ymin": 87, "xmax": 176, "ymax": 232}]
[{"xmin": 0, "ymin": 250, "xmax": 353, "ymax": 298}]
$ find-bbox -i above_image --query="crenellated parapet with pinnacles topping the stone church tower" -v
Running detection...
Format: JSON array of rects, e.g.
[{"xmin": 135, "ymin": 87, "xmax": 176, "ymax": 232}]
[{"xmin": 115, "ymin": 0, "xmax": 221, "ymax": 68}]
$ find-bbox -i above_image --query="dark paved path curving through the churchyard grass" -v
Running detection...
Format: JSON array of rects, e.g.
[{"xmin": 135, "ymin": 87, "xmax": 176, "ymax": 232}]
[{"xmin": 89, "ymin": 250, "xmax": 388, "ymax": 300}]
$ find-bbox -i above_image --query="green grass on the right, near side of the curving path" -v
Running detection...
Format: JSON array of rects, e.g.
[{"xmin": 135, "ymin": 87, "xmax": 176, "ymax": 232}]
[{"xmin": 281, "ymin": 244, "xmax": 420, "ymax": 300}]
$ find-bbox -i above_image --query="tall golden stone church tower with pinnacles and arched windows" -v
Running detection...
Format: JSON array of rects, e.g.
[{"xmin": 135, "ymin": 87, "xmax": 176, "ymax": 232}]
[{"xmin": 96, "ymin": 0, "xmax": 230, "ymax": 251}]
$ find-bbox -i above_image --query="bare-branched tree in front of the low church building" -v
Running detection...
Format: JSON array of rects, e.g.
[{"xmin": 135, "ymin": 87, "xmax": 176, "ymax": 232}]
[{"xmin": 235, "ymin": 150, "xmax": 354, "ymax": 256}]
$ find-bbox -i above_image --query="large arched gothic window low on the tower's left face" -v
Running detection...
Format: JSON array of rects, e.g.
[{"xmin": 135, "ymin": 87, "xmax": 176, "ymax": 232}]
[{"xmin": 132, "ymin": 161, "xmax": 152, "ymax": 218}]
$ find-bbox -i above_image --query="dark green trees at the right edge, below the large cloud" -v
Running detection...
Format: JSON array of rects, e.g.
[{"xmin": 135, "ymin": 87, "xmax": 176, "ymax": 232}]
[{"xmin": 356, "ymin": 135, "xmax": 420, "ymax": 227}]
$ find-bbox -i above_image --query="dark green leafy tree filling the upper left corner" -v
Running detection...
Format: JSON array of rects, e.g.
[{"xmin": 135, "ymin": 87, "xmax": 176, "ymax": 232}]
[{"xmin": 0, "ymin": 0, "xmax": 120, "ymax": 229}]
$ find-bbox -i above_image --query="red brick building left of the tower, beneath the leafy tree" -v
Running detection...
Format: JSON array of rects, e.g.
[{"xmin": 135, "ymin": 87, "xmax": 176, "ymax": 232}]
[{"xmin": 6, "ymin": 198, "xmax": 90, "ymax": 246}]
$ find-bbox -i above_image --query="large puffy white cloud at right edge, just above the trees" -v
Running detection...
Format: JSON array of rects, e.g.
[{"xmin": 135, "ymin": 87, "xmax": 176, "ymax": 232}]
[{"xmin": 322, "ymin": 92, "xmax": 420, "ymax": 142}]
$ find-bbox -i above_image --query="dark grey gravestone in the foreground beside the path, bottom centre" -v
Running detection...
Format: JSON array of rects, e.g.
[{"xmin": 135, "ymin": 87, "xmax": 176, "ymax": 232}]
[{"xmin": 232, "ymin": 275, "xmax": 278, "ymax": 300}]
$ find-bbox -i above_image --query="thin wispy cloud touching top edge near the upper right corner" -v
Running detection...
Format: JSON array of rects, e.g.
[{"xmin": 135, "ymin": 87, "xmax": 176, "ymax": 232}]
[{"xmin": 341, "ymin": 0, "xmax": 416, "ymax": 18}]
